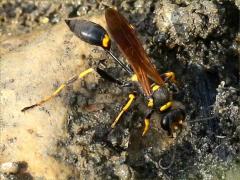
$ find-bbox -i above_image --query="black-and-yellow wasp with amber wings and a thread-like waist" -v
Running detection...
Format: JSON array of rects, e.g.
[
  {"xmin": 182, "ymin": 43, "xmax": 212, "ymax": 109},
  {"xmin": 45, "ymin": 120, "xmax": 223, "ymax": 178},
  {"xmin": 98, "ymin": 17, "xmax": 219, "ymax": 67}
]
[{"xmin": 22, "ymin": 8, "xmax": 185, "ymax": 137}]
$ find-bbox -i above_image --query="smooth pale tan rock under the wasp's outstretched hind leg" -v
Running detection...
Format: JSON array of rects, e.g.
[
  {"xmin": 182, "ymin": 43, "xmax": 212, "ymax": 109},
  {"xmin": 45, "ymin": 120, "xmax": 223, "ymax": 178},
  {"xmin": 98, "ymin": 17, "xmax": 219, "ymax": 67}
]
[{"xmin": 0, "ymin": 16, "xmax": 104, "ymax": 180}]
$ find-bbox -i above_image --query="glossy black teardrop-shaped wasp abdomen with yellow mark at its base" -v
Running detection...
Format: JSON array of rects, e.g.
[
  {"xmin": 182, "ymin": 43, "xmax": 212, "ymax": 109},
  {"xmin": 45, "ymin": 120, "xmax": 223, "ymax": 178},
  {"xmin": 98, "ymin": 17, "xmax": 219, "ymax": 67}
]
[{"xmin": 65, "ymin": 19, "xmax": 111, "ymax": 50}]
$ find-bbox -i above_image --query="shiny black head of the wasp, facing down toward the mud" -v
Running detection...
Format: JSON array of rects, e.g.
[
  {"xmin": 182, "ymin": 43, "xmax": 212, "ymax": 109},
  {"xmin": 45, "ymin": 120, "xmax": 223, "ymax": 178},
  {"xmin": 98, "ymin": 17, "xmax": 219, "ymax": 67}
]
[{"xmin": 161, "ymin": 109, "xmax": 185, "ymax": 135}]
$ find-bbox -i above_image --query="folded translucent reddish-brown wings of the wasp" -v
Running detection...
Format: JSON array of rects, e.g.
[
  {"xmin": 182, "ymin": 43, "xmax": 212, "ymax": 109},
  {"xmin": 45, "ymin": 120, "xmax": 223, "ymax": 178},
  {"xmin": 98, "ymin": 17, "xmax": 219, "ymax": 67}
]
[{"xmin": 105, "ymin": 8, "xmax": 164, "ymax": 95}]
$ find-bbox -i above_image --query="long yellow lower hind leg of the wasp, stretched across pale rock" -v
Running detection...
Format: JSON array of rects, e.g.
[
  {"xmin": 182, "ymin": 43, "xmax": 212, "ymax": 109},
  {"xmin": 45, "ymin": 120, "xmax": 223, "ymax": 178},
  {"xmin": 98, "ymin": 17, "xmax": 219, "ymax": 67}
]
[{"xmin": 21, "ymin": 68, "xmax": 94, "ymax": 112}]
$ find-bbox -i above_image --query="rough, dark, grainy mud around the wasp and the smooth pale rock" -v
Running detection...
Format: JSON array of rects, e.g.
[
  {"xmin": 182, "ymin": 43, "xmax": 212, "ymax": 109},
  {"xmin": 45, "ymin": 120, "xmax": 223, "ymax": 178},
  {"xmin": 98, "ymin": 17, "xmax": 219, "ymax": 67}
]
[{"xmin": 0, "ymin": 0, "xmax": 240, "ymax": 179}]
